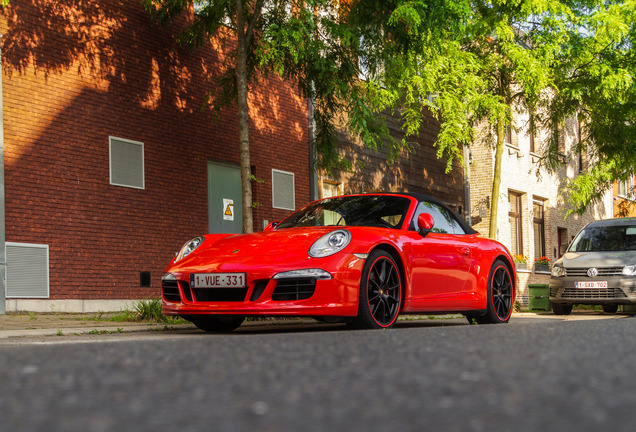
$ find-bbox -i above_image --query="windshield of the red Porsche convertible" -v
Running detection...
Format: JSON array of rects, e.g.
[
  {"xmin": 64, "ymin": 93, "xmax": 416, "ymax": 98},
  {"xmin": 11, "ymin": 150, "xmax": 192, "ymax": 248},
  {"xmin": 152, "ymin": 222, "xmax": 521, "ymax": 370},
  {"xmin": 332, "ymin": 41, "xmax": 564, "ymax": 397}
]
[{"xmin": 277, "ymin": 195, "xmax": 411, "ymax": 229}]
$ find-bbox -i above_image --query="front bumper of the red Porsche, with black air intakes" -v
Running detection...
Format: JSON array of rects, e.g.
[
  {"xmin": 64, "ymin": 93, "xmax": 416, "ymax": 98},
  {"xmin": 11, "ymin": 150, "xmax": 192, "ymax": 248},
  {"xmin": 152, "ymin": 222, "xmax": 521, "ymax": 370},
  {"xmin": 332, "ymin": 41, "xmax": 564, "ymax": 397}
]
[{"xmin": 162, "ymin": 255, "xmax": 364, "ymax": 317}]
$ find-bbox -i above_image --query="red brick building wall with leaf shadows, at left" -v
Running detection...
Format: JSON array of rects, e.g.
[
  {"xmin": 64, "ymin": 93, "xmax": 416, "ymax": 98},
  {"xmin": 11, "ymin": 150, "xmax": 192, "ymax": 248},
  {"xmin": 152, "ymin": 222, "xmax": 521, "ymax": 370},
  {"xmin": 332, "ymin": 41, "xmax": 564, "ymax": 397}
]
[{"xmin": 0, "ymin": 0, "xmax": 309, "ymax": 306}]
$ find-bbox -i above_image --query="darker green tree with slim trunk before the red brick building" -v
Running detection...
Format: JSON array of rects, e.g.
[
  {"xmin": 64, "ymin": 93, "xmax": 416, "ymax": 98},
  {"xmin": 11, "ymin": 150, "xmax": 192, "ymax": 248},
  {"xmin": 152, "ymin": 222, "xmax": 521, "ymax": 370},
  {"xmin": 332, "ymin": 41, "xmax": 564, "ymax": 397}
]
[{"xmin": 144, "ymin": 0, "xmax": 474, "ymax": 232}]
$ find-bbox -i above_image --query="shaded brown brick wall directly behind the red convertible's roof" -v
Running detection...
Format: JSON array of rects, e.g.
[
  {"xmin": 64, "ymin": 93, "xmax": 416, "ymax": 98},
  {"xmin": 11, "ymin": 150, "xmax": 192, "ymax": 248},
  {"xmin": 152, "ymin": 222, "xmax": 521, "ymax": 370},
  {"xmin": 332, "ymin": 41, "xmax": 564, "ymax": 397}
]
[{"xmin": 319, "ymin": 109, "xmax": 466, "ymax": 213}]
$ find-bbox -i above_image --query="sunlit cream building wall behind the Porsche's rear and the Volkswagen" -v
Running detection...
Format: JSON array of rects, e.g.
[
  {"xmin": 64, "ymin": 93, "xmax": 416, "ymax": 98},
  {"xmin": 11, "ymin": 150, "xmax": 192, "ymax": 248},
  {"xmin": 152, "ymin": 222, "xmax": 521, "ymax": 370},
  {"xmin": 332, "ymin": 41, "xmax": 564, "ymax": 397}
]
[{"xmin": 470, "ymin": 112, "xmax": 613, "ymax": 305}]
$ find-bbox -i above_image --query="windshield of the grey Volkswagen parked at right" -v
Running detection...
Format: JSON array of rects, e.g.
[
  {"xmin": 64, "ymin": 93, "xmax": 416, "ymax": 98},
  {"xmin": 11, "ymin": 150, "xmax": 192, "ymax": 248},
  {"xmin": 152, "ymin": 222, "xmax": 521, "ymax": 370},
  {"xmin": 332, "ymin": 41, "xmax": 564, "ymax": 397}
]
[{"xmin": 570, "ymin": 226, "xmax": 636, "ymax": 252}]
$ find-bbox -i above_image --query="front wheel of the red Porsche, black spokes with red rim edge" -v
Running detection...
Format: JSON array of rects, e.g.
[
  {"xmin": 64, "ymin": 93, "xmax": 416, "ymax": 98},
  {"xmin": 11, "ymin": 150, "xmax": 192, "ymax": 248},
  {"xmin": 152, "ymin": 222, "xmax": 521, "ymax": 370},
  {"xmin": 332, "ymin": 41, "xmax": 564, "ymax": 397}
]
[{"xmin": 351, "ymin": 250, "xmax": 403, "ymax": 329}]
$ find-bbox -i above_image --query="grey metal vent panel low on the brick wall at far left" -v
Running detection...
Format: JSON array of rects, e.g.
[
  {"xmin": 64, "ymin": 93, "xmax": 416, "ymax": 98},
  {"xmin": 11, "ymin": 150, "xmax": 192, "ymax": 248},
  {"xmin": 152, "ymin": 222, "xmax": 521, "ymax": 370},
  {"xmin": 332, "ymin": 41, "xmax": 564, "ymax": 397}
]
[{"xmin": 7, "ymin": 243, "xmax": 49, "ymax": 298}]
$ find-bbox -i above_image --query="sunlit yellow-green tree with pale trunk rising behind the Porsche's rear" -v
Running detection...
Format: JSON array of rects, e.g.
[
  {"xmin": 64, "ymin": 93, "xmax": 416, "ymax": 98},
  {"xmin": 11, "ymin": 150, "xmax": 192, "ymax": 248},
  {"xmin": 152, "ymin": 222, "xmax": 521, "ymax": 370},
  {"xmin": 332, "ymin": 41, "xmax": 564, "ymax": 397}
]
[{"xmin": 376, "ymin": 1, "xmax": 550, "ymax": 238}]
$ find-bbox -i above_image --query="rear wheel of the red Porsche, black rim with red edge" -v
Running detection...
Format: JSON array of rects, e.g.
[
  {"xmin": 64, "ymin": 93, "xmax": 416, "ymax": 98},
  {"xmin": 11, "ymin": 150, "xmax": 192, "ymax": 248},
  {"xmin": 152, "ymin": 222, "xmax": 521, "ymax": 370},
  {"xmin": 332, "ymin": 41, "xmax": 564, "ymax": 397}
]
[{"xmin": 466, "ymin": 260, "xmax": 514, "ymax": 324}]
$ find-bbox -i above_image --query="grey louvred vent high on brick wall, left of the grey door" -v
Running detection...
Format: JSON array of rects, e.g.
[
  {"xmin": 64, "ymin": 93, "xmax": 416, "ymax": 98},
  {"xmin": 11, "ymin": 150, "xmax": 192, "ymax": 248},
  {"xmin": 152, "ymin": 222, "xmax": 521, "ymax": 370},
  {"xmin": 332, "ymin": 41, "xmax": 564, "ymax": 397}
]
[{"xmin": 109, "ymin": 137, "xmax": 146, "ymax": 189}]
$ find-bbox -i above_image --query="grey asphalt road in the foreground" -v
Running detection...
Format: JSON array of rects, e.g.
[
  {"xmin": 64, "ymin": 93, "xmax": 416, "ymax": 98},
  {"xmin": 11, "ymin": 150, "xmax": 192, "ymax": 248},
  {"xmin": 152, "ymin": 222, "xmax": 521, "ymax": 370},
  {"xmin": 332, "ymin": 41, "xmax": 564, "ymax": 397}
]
[{"xmin": 0, "ymin": 317, "xmax": 636, "ymax": 432}]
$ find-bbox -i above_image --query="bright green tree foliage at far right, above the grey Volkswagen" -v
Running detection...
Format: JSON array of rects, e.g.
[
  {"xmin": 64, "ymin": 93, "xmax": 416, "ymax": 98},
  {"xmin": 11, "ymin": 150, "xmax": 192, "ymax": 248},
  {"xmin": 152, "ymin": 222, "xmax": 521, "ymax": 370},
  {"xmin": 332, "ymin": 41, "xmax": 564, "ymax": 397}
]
[{"xmin": 549, "ymin": 1, "xmax": 636, "ymax": 214}]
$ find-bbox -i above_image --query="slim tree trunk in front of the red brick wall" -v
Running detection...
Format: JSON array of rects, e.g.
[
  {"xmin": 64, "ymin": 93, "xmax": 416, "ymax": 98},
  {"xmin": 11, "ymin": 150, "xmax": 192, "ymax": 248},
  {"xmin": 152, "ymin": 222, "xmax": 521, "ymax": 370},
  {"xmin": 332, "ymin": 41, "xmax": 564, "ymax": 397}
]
[{"xmin": 235, "ymin": 0, "xmax": 254, "ymax": 233}]
